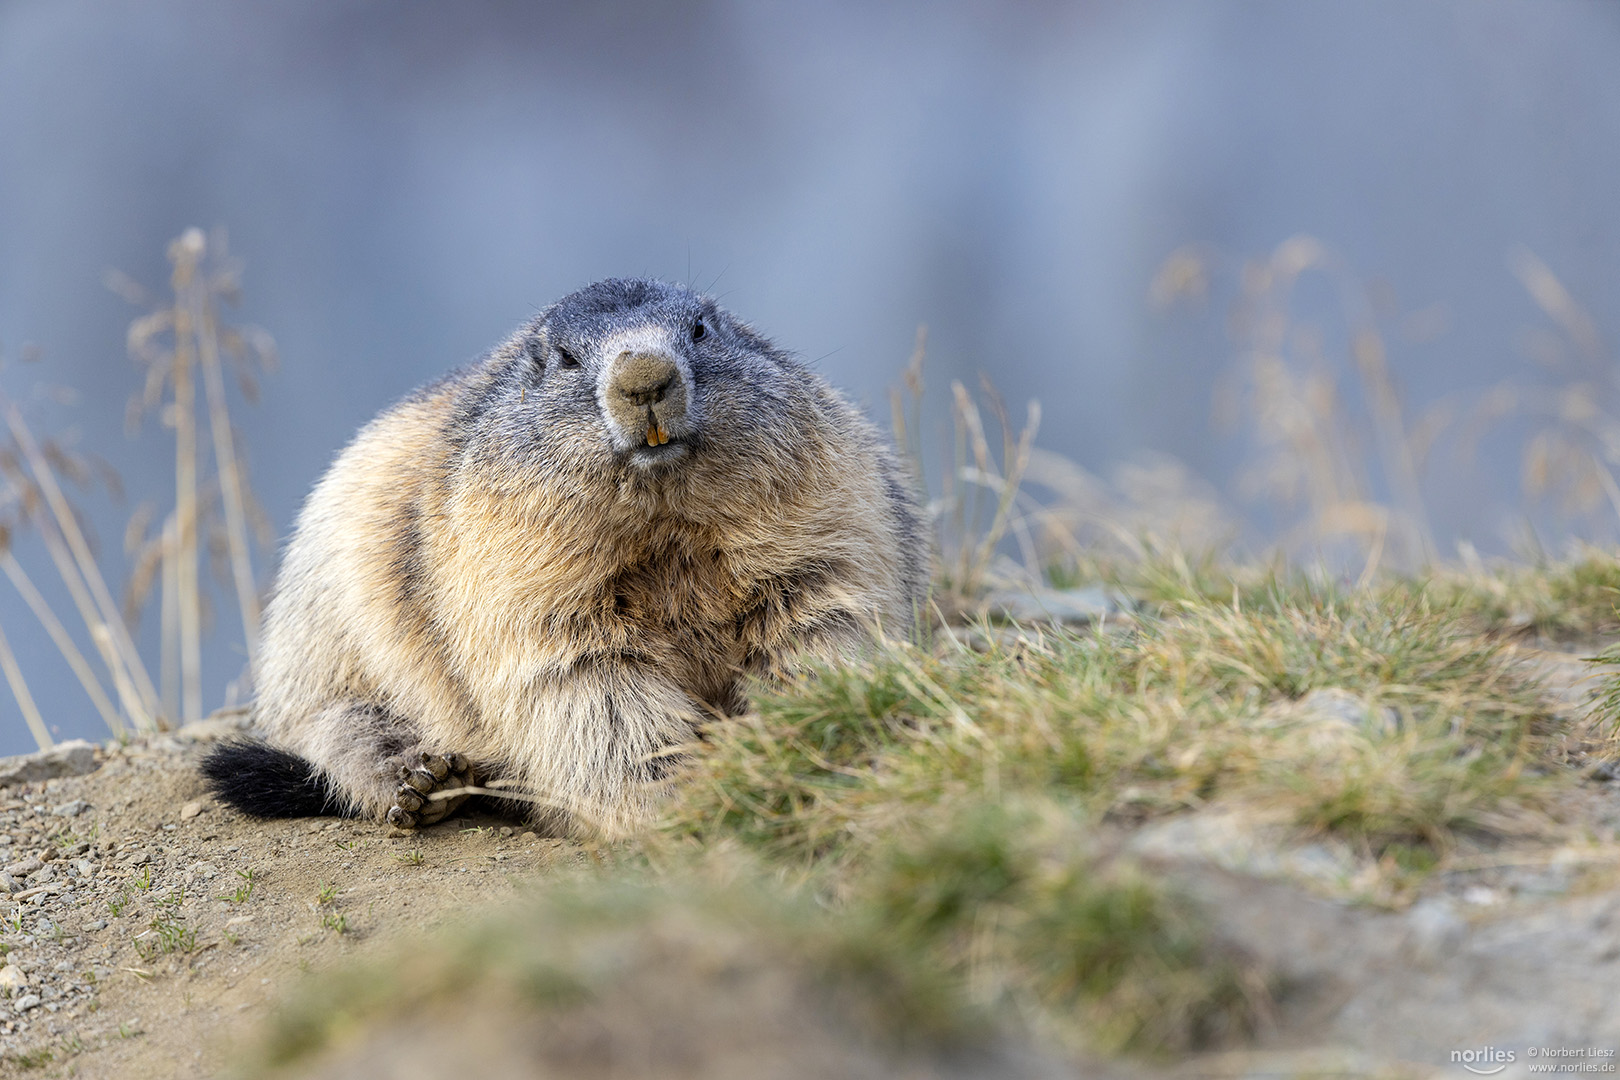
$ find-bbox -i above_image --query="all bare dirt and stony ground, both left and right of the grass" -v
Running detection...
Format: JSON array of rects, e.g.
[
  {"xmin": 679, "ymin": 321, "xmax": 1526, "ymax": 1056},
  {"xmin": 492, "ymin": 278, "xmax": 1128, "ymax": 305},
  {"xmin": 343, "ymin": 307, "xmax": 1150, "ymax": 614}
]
[{"xmin": 0, "ymin": 653, "xmax": 1620, "ymax": 1080}]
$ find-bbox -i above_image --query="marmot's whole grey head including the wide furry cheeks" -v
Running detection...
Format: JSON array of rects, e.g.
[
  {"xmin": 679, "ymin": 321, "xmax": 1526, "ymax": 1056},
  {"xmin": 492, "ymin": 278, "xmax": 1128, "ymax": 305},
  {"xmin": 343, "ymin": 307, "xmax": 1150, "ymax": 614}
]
[{"xmin": 473, "ymin": 279, "xmax": 816, "ymax": 498}]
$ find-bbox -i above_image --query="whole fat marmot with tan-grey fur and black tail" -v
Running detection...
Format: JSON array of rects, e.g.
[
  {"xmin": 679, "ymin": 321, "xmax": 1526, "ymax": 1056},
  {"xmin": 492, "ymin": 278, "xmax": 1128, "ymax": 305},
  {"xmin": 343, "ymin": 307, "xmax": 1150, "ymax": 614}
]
[{"xmin": 203, "ymin": 279, "xmax": 928, "ymax": 836}]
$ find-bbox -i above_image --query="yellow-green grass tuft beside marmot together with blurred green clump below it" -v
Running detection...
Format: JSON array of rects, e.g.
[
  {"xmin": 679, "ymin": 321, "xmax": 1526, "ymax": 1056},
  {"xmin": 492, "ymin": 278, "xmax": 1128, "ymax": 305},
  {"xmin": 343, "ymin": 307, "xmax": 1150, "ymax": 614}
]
[{"xmin": 653, "ymin": 585, "xmax": 1580, "ymax": 1051}]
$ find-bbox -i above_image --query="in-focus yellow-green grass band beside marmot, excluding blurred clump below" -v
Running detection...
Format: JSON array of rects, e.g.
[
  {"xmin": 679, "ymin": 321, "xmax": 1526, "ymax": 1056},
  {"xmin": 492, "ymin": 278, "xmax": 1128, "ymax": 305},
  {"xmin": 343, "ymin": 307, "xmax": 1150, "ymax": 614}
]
[{"xmin": 672, "ymin": 593, "xmax": 1557, "ymax": 865}]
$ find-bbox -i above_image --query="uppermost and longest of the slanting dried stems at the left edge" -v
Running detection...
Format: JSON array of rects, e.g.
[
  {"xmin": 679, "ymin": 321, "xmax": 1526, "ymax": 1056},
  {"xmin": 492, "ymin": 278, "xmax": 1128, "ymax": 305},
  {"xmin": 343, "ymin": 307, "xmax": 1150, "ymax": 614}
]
[{"xmin": 5, "ymin": 402, "xmax": 159, "ymax": 730}]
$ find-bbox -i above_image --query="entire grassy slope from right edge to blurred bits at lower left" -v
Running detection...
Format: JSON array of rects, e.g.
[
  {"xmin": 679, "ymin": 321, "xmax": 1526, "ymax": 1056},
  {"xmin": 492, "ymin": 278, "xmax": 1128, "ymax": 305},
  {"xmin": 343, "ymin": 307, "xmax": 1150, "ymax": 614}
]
[{"xmin": 243, "ymin": 557, "xmax": 1617, "ymax": 1061}]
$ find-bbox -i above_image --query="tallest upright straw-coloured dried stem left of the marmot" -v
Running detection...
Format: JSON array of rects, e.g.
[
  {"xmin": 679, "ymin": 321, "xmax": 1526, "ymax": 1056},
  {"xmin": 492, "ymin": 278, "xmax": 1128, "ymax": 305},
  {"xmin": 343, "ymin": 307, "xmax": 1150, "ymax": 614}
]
[{"xmin": 168, "ymin": 241, "xmax": 203, "ymax": 724}]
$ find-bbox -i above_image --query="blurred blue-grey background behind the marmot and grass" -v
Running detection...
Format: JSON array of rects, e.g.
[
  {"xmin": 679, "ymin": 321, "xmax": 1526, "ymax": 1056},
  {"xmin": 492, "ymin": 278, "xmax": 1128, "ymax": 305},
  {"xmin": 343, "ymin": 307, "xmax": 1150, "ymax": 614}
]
[{"xmin": 0, "ymin": 0, "xmax": 1620, "ymax": 753}]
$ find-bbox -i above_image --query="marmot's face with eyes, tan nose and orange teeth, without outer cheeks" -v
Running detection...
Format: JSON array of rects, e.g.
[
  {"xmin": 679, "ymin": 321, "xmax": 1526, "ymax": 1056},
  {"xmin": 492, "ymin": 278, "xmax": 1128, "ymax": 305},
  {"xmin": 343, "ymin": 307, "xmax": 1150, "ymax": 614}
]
[{"xmin": 518, "ymin": 279, "xmax": 786, "ymax": 473}]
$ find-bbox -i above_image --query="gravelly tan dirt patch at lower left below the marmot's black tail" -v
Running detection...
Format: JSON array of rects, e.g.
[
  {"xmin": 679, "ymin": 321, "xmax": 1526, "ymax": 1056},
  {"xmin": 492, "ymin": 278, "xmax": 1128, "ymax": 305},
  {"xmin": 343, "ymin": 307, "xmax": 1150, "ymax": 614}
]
[{"xmin": 0, "ymin": 732, "xmax": 586, "ymax": 1080}]
